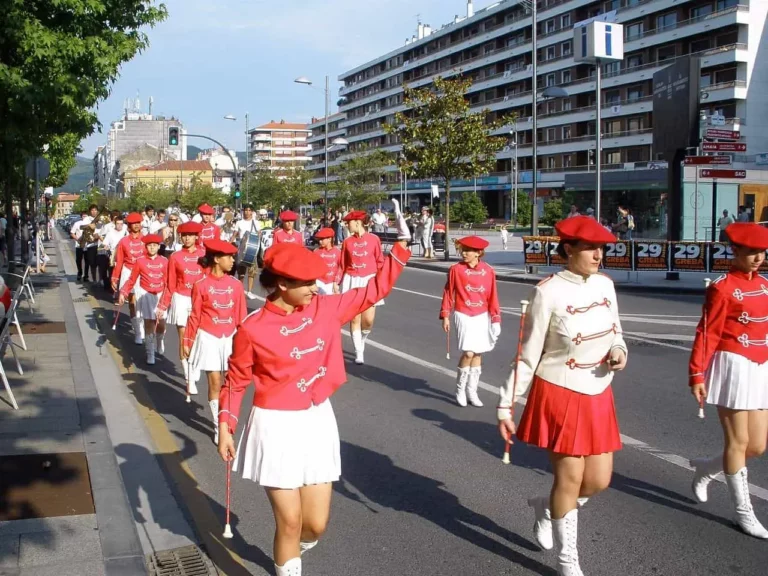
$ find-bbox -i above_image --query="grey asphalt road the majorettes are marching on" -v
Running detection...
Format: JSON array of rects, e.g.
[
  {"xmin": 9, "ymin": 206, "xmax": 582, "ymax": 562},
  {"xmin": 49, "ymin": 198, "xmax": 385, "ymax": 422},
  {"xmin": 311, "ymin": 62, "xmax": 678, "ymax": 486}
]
[{"xmin": 93, "ymin": 270, "xmax": 768, "ymax": 576}]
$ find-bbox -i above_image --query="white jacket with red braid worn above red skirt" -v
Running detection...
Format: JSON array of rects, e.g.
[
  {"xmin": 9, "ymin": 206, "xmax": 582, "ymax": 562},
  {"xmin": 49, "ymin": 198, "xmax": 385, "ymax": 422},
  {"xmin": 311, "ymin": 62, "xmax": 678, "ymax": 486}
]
[{"xmin": 498, "ymin": 270, "xmax": 627, "ymax": 420}]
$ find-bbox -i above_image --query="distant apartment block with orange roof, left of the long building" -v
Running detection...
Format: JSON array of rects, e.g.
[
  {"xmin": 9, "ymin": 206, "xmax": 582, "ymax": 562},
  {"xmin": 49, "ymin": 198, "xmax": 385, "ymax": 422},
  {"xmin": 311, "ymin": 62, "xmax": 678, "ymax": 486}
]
[{"xmin": 248, "ymin": 120, "xmax": 311, "ymax": 177}]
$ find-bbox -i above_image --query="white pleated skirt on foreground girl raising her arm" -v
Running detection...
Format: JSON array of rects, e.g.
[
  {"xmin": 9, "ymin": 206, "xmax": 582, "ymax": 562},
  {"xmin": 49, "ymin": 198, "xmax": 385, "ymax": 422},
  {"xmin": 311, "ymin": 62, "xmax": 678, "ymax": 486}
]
[{"xmin": 233, "ymin": 400, "xmax": 341, "ymax": 490}]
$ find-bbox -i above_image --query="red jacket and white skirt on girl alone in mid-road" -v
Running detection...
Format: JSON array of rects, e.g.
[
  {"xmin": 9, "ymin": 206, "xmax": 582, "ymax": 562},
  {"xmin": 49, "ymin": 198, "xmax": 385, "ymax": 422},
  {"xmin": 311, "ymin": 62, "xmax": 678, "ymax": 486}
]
[{"xmin": 440, "ymin": 261, "xmax": 501, "ymax": 354}]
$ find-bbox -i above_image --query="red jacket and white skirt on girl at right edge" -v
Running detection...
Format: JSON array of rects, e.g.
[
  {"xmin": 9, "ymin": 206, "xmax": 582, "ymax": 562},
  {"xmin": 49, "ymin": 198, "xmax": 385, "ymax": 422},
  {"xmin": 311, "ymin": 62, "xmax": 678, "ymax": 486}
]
[{"xmin": 689, "ymin": 270, "xmax": 768, "ymax": 410}]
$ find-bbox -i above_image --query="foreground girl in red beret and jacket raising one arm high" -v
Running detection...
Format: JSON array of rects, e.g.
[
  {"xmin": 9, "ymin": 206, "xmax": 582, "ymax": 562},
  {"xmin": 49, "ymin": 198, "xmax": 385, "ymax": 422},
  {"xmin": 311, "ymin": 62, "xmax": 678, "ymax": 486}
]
[{"xmin": 219, "ymin": 237, "xmax": 410, "ymax": 576}]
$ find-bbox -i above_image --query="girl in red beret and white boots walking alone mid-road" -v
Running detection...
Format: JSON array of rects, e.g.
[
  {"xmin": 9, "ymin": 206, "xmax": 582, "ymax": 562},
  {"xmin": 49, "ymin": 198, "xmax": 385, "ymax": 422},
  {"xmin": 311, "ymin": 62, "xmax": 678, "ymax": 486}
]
[{"xmin": 440, "ymin": 236, "xmax": 501, "ymax": 406}]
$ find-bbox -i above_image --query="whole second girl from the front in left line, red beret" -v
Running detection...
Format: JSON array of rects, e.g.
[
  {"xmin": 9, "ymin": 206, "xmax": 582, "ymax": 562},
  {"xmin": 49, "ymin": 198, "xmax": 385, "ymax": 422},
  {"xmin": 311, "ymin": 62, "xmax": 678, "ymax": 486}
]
[{"xmin": 183, "ymin": 239, "xmax": 247, "ymax": 444}]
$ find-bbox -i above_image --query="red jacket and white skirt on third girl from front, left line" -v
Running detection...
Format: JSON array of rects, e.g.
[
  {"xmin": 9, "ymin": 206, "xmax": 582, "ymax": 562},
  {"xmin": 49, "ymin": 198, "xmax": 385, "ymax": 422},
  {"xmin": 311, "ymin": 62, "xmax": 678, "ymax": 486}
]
[{"xmin": 157, "ymin": 247, "xmax": 205, "ymax": 326}]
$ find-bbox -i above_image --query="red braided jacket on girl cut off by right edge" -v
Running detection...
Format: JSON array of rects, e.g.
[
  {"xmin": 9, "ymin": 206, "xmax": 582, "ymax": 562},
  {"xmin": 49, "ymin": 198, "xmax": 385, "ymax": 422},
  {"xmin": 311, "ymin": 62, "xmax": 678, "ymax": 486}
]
[{"xmin": 688, "ymin": 270, "xmax": 768, "ymax": 386}]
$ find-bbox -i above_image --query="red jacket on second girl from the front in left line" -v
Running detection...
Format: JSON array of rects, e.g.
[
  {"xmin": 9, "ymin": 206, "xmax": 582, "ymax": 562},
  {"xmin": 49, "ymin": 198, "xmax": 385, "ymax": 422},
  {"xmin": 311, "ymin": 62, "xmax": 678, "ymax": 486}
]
[{"xmin": 184, "ymin": 274, "xmax": 248, "ymax": 346}]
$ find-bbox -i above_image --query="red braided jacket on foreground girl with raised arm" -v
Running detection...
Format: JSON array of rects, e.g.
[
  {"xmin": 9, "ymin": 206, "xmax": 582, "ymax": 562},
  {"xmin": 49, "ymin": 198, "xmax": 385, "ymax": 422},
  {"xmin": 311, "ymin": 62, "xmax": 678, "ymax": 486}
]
[{"xmin": 219, "ymin": 245, "xmax": 411, "ymax": 434}]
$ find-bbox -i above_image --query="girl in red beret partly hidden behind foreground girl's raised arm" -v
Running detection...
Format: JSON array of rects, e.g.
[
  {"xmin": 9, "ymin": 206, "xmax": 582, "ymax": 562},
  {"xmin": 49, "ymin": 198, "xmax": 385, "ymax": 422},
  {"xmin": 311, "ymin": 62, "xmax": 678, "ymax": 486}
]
[{"xmin": 339, "ymin": 210, "xmax": 384, "ymax": 364}]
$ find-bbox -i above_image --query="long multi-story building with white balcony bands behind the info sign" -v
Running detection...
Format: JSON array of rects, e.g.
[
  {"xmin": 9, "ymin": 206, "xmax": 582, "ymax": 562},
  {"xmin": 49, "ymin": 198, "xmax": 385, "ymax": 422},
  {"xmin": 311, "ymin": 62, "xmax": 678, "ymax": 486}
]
[{"xmin": 332, "ymin": 0, "xmax": 768, "ymax": 234}]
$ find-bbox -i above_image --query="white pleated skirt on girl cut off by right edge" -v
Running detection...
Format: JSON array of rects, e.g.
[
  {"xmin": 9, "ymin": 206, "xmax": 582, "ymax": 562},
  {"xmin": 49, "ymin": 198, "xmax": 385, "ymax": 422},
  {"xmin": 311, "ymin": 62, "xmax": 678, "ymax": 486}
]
[{"xmin": 707, "ymin": 351, "xmax": 768, "ymax": 410}]
